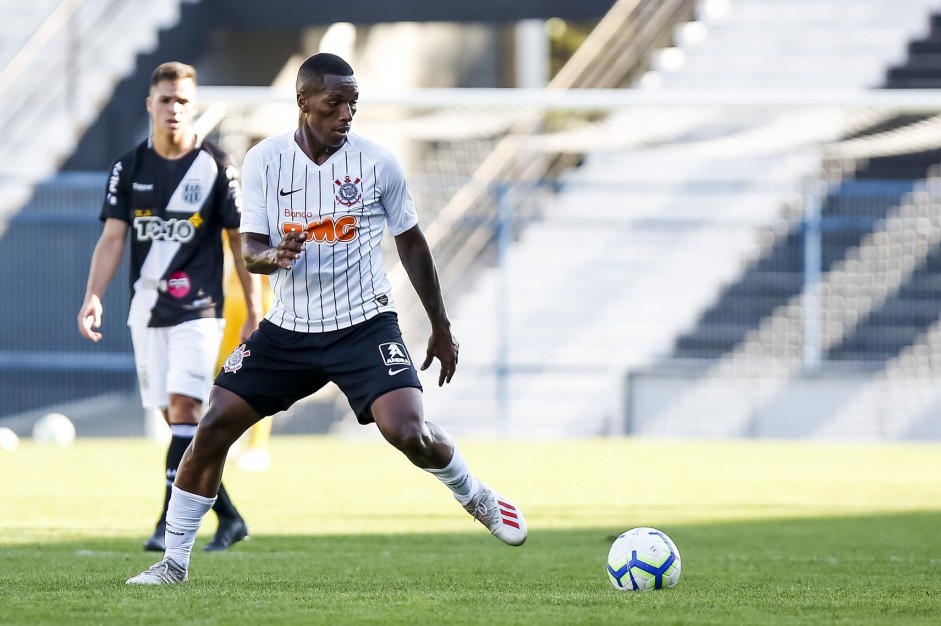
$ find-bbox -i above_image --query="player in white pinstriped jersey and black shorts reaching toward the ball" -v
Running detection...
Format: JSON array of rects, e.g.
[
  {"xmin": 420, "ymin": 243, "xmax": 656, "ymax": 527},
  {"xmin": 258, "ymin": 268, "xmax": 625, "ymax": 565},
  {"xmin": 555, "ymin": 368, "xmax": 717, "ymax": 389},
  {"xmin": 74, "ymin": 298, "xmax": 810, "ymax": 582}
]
[{"xmin": 127, "ymin": 53, "xmax": 527, "ymax": 585}]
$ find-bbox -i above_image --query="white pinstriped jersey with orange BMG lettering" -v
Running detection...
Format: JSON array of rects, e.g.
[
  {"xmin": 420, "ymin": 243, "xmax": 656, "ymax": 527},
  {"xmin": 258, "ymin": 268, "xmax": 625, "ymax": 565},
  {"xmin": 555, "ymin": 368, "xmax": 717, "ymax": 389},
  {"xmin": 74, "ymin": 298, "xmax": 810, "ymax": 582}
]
[{"xmin": 240, "ymin": 132, "xmax": 418, "ymax": 333}]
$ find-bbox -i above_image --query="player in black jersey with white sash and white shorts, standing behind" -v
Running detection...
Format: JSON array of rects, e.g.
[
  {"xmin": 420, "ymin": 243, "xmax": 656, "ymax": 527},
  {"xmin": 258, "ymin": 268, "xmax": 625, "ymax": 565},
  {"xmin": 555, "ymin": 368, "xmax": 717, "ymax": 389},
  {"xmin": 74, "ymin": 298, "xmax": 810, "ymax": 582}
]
[{"xmin": 78, "ymin": 62, "xmax": 262, "ymax": 552}]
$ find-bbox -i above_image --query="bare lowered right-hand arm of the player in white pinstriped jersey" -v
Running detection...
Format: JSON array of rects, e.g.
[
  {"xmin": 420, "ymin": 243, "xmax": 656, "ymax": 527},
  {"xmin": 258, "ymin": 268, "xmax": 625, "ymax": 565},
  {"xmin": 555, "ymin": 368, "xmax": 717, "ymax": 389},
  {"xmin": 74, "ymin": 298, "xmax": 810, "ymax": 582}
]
[{"xmin": 395, "ymin": 225, "xmax": 460, "ymax": 387}]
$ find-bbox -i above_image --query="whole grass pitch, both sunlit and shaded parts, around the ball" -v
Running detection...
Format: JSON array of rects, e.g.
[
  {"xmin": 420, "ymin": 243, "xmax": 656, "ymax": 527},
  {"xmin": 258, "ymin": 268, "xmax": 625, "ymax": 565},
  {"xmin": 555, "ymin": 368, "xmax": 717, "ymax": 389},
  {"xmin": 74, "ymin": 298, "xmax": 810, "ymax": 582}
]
[{"xmin": 0, "ymin": 437, "xmax": 941, "ymax": 626}]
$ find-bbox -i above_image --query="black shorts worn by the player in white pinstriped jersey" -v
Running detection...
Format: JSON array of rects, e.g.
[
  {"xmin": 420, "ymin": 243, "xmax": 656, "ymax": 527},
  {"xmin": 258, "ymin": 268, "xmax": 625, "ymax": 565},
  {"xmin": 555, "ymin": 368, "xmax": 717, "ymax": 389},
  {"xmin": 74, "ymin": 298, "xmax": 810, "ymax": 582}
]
[{"xmin": 215, "ymin": 312, "xmax": 422, "ymax": 424}]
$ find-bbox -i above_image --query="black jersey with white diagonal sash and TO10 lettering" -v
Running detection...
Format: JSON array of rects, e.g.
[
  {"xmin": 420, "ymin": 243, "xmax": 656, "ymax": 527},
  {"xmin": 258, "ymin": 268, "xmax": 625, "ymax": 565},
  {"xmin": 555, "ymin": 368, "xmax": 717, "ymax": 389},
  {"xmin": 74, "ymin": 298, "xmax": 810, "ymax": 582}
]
[{"xmin": 100, "ymin": 139, "xmax": 241, "ymax": 326}]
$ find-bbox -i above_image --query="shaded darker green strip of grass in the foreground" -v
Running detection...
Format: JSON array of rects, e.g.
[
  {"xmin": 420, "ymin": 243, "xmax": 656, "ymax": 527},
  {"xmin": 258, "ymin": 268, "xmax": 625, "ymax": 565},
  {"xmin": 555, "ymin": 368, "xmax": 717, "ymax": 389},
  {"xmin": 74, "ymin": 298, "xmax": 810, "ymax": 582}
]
[{"xmin": 0, "ymin": 511, "xmax": 941, "ymax": 626}]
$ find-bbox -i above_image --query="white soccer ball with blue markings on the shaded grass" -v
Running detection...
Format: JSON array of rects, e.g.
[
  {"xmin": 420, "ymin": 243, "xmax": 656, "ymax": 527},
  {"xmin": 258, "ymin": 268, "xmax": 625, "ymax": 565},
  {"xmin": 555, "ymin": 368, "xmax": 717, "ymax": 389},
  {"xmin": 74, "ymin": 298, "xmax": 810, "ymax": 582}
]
[{"xmin": 608, "ymin": 527, "xmax": 680, "ymax": 591}]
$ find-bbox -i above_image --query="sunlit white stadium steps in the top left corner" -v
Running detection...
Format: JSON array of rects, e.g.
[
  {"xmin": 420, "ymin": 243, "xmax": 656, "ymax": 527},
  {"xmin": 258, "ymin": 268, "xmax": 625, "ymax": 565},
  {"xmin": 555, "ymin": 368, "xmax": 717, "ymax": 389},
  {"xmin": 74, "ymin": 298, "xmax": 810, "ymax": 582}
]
[{"xmin": 0, "ymin": 0, "xmax": 188, "ymax": 236}]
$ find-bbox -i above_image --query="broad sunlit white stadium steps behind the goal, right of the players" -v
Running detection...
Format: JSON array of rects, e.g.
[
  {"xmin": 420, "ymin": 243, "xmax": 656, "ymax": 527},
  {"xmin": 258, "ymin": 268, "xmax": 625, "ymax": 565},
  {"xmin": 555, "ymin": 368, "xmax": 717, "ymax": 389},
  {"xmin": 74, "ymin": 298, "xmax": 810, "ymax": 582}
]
[{"xmin": 426, "ymin": 0, "xmax": 941, "ymax": 437}]
